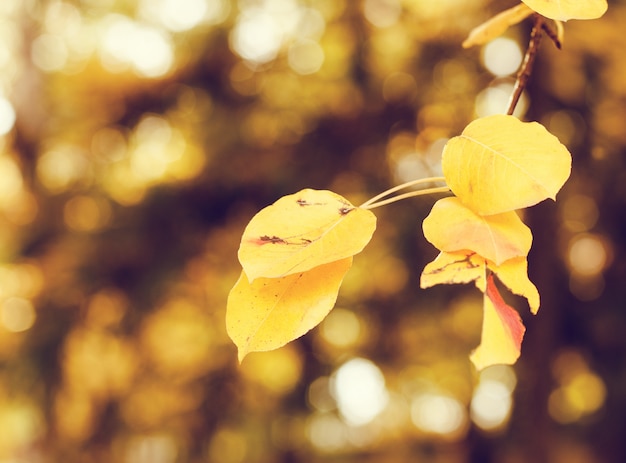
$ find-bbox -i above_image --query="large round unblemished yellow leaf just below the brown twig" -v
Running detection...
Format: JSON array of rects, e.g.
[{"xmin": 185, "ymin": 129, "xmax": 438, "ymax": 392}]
[{"xmin": 442, "ymin": 115, "xmax": 572, "ymax": 215}]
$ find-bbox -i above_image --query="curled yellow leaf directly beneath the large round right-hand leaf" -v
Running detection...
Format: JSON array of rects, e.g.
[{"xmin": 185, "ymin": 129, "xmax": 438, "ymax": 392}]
[{"xmin": 422, "ymin": 197, "xmax": 532, "ymax": 265}]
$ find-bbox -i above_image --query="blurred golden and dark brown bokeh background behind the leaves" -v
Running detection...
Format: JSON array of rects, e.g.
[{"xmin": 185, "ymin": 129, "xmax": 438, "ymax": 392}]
[{"xmin": 0, "ymin": 0, "xmax": 626, "ymax": 463}]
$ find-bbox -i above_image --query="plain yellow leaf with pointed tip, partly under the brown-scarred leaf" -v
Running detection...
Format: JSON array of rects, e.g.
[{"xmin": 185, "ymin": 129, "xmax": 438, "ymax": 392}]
[{"xmin": 226, "ymin": 257, "xmax": 352, "ymax": 362}]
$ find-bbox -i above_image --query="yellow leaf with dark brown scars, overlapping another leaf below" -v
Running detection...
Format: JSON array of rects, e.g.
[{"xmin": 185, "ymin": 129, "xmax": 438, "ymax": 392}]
[{"xmin": 239, "ymin": 189, "xmax": 376, "ymax": 282}]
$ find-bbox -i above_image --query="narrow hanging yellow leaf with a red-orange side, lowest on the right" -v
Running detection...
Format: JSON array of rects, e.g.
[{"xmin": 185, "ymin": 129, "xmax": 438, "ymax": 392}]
[{"xmin": 470, "ymin": 275, "xmax": 526, "ymax": 370}]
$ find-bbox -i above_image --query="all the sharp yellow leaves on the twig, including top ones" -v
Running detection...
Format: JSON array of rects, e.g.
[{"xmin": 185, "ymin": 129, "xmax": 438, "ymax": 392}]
[{"xmin": 226, "ymin": 0, "xmax": 606, "ymax": 369}]
